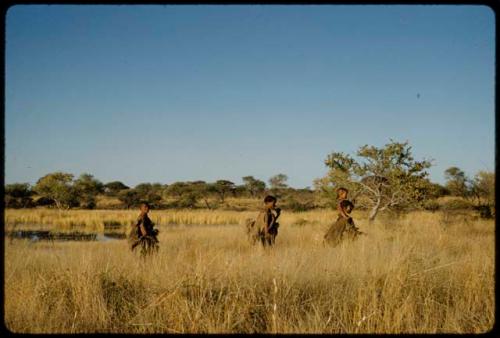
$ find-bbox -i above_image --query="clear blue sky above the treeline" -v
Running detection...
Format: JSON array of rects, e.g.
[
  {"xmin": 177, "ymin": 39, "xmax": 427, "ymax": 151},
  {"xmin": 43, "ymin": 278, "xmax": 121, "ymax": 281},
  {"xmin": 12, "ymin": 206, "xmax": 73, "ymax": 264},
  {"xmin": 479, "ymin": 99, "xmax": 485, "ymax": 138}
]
[{"xmin": 5, "ymin": 5, "xmax": 495, "ymax": 188}]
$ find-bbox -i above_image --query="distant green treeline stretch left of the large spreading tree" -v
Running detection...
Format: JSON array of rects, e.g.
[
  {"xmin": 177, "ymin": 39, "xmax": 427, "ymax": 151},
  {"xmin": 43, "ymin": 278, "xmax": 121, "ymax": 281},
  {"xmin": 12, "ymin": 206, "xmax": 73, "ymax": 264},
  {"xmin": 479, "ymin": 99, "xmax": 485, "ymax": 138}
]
[{"xmin": 5, "ymin": 172, "xmax": 315, "ymax": 210}]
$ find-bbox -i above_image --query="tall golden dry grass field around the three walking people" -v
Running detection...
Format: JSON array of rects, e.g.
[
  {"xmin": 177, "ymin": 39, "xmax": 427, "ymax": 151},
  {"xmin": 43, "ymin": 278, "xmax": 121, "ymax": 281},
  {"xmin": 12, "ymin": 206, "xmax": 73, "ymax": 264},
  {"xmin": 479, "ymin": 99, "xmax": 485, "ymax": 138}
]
[{"xmin": 4, "ymin": 210, "xmax": 495, "ymax": 333}]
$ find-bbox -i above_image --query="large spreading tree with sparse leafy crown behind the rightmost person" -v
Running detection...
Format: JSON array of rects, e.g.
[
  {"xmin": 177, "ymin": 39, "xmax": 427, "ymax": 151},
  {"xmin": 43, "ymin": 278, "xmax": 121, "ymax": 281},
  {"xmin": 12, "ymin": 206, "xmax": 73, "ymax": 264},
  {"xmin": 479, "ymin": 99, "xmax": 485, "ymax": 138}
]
[{"xmin": 315, "ymin": 140, "xmax": 431, "ymax": 221}]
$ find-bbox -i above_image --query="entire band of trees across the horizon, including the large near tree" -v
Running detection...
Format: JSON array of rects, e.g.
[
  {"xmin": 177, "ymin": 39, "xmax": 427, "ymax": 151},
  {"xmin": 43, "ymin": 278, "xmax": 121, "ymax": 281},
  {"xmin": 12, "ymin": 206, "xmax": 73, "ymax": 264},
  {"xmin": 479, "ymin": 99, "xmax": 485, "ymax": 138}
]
[{"xmin": 5, "ymin": 140, "xmax": 495, "ymax": 220}]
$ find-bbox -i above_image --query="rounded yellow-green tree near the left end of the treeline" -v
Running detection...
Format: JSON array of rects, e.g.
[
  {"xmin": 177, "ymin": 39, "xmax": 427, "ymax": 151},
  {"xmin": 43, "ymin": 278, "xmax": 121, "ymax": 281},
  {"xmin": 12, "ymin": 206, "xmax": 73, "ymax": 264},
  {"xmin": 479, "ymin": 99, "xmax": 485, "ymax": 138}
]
[{"xmin": 34, "ymin": 172, "xmax": 78, "ymax": 209}]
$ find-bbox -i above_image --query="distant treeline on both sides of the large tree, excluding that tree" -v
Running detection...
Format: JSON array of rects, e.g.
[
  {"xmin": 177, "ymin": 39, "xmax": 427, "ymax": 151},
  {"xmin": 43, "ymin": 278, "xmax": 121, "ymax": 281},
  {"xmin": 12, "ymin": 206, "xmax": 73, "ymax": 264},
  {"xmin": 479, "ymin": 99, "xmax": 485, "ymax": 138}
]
[{"xmin": 5, "ymin": 167, "xmax": 495, "ymax": 215}]
